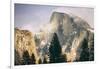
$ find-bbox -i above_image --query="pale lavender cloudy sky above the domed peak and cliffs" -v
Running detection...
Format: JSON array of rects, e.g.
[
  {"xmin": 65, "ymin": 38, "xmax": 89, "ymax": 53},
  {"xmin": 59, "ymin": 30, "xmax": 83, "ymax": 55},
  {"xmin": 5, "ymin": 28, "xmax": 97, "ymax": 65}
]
[{"xmin": 14, "ymin": 3, "xmax": 94, "ymax": 32}]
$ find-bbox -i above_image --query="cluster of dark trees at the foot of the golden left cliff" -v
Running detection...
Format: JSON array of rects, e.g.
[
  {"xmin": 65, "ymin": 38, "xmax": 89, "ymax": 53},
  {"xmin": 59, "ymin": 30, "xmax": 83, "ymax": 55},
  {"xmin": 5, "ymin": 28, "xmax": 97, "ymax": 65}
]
[{"xmin": 15, "ymin": 50, "xmax": 35, "ymax": 65}]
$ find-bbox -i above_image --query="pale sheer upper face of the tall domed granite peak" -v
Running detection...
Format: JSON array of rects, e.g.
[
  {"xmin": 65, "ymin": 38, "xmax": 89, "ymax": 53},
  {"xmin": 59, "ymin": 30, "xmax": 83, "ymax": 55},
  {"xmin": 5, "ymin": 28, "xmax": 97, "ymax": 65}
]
[{"xmin": 50, "ymin": 12, "xmax": 73, "ymax": 36}]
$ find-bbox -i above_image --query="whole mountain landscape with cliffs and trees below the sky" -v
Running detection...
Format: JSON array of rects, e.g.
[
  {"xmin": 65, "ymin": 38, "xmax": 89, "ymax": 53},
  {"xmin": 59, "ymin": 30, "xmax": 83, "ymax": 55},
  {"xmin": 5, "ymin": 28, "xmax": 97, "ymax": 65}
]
[{"xmin": 15, "ymin": 12, "xmax": 94, "ymax": 65}]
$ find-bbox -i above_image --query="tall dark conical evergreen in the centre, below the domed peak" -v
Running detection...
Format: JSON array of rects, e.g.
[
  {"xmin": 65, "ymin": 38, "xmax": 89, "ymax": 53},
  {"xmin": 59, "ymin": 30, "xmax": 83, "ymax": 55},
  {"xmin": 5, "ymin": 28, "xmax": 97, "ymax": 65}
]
[{"xmin": 49, "ymin": 33, "xmax": 65, "ymax": 63}]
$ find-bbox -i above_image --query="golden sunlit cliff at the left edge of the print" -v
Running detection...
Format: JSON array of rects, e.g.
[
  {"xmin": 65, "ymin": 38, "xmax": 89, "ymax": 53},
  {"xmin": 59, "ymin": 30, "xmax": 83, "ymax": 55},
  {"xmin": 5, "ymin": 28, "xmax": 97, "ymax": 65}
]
[{"xmin": 15, "ymin": 28, "xmax": 38, "ymax": 65}]
